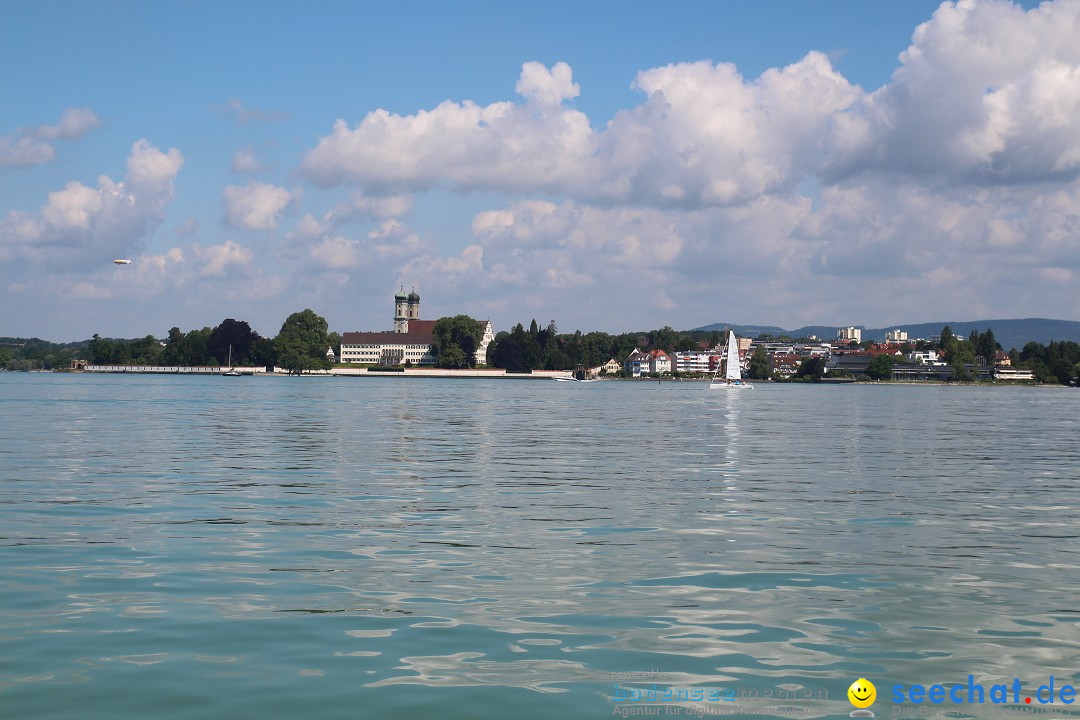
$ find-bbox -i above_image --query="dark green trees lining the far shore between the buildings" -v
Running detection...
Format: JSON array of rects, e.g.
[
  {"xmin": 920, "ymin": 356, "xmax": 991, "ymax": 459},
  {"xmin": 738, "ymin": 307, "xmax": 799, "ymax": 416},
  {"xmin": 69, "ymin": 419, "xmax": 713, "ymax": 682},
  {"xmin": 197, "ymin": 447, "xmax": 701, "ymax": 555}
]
[{"xmin": 0, "ymin": 309, "xmax": 1080, "ymax": 384}]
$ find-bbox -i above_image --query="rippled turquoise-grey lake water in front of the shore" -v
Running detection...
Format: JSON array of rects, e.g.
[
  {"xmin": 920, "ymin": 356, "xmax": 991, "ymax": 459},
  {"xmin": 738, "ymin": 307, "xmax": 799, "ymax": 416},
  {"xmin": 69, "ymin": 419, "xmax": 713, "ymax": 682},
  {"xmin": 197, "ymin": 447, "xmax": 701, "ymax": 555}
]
[{"xmin": 0, "ymin": 372, "xmax": 1080, "ymax": 720}]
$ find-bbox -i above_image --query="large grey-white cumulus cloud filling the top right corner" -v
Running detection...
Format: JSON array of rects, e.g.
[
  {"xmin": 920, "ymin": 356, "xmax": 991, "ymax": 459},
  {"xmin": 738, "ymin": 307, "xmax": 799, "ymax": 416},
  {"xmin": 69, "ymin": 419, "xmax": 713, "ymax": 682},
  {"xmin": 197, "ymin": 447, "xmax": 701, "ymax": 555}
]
[{"xmin": 827, "ymin": 0, "xmax": 1080, "ymax": 185}]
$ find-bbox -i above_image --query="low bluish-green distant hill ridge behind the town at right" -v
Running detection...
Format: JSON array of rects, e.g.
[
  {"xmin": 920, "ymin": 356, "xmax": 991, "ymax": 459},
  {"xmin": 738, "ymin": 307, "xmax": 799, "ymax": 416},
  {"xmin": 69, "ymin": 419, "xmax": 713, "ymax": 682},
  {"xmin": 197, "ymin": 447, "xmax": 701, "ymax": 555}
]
[{"xmin": 694, "ymin": 317, "xmax": 1080, "ymax": 350}]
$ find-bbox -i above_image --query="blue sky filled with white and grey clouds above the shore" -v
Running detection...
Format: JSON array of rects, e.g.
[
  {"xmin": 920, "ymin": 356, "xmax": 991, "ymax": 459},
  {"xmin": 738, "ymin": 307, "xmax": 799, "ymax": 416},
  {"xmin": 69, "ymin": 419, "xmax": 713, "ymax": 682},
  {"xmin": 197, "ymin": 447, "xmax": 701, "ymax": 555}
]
[{"xmin": 0, "ymin": 0, "xmax": 1080, "ymax": 341}]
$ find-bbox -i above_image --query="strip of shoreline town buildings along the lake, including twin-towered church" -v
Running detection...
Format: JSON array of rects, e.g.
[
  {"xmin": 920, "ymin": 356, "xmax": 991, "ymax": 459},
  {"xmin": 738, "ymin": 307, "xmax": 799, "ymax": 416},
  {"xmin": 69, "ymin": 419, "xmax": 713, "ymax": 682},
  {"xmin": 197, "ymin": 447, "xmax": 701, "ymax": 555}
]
[{"xmin": 8, "ymin": 288, "xmax": 1080, "ymax": 385}]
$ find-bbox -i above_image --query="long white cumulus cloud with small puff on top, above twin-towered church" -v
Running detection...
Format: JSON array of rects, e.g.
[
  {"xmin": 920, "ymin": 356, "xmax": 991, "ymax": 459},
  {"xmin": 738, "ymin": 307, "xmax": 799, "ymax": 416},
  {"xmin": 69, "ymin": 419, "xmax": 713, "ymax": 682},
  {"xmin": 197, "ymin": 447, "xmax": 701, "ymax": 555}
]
[{"xmin": 302, "ymin": 53, "xmax": 861, "ymax": 206}]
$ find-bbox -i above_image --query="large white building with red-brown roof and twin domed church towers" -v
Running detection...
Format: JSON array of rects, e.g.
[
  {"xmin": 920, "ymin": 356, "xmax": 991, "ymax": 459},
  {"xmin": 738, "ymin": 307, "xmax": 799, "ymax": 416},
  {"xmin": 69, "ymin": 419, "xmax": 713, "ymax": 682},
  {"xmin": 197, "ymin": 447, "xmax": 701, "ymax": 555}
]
[{"xmin": 341, "ymin": 288, "xmax": 495, "ymax": 365}]
